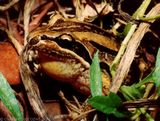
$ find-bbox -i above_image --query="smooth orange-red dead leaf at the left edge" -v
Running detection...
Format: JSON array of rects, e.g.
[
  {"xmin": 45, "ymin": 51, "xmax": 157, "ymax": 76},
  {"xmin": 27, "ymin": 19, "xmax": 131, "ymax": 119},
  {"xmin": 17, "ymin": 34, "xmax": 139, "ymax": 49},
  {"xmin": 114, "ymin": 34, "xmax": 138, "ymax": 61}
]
[{"xmin": 0, "ymin": 42, "xmax": 21, "ymax": 85}]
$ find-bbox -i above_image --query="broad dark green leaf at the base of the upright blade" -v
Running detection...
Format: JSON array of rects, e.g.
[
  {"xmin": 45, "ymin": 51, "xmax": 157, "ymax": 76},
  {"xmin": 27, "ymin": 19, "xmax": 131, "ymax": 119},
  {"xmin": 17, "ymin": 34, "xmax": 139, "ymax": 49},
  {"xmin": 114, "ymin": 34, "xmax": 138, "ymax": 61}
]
[{"xmin": 88, "ymin": 92, "xmax": 126, "ymax": 118}]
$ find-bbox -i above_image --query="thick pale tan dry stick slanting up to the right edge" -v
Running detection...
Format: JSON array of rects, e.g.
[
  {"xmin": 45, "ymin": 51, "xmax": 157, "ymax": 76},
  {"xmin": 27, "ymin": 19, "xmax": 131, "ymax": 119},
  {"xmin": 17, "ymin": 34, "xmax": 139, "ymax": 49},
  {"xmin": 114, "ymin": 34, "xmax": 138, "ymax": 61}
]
[{"xmin": 110, "ymin": 4, "xmax": 160, "ymax": 93}]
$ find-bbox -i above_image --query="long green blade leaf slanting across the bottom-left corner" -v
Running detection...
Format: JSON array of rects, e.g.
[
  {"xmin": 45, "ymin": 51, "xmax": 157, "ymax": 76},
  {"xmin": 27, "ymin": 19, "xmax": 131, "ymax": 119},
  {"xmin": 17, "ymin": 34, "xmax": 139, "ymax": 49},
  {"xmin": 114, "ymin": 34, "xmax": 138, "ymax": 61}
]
[{"xmin": 0, "ymin": 73, "xmax": 23, "ymax": 121}]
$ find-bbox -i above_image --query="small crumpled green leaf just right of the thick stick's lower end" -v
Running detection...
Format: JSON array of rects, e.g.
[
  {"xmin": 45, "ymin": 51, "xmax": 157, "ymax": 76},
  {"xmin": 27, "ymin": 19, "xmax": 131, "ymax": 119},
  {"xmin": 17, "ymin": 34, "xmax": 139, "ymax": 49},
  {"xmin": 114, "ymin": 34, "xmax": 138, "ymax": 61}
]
[{"xmin": 120, "ymin": 84, "xmax": 145, "ymax": 100}]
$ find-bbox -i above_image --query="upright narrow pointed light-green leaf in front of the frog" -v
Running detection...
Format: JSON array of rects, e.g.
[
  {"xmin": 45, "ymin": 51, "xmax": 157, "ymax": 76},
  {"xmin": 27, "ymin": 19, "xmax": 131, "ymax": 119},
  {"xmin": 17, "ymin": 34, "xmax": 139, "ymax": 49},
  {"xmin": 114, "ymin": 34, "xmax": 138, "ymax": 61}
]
[{"xmin": 90, "ymin": 51, "xmax": 102, "ymax": 97}]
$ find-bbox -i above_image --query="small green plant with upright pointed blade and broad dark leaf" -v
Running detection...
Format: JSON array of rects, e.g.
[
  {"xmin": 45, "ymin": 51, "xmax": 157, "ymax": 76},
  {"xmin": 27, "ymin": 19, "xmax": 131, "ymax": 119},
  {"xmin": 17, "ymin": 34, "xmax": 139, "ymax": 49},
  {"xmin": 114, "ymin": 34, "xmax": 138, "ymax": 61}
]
[{"xmin": 88, "ymin": 52, "xmax": 126, "ymax": 120}]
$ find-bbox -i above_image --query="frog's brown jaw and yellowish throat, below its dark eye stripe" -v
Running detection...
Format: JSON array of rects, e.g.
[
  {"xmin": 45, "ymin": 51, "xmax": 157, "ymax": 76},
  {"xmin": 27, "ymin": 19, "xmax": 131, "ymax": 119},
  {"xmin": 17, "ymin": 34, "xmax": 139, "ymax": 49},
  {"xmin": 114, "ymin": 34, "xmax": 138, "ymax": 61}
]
[{"xmin": 34, "ymin": 40, "xmax": 90, "ymax": 82}]
